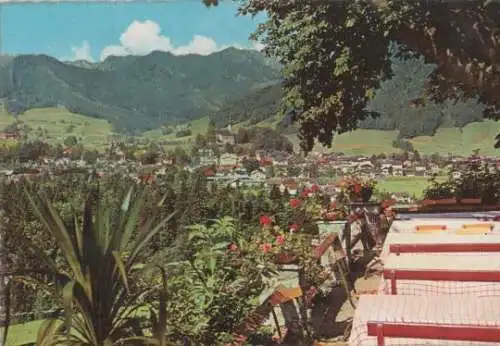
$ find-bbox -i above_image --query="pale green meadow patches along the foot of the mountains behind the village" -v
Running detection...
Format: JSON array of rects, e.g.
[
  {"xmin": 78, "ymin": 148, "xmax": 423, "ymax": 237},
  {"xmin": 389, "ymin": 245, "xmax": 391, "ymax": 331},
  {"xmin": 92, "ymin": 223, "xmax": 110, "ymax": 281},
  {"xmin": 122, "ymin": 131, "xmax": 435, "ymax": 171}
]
[{"xmin": 0, "ymin": 108, "xmax": 500, "ymax": 156}]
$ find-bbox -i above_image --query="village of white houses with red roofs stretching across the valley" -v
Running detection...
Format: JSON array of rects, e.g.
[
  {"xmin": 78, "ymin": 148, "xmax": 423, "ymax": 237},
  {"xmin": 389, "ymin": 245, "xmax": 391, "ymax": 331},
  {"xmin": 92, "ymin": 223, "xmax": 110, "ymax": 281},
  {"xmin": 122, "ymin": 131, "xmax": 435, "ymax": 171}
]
[{"xmin": 0, "ymin": 125, "xmax": 500, "ymax": 208}]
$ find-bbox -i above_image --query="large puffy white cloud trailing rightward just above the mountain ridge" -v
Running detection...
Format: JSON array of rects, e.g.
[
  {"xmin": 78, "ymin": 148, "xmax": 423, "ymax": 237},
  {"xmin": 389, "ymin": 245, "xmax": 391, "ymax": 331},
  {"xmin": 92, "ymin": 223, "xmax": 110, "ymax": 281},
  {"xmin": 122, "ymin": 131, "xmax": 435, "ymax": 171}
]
[{"xmin": 100, "ymin": 20, "xmax": 268, "ymax": 60}]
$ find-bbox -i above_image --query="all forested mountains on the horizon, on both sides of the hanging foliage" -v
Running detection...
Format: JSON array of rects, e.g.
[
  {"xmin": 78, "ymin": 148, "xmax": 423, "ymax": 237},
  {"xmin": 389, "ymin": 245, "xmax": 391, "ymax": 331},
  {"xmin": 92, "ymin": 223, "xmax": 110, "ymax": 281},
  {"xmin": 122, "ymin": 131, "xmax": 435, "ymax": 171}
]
[{"xmin": 0, "ymin": 48, "xmax": 492, "ymax": 138}]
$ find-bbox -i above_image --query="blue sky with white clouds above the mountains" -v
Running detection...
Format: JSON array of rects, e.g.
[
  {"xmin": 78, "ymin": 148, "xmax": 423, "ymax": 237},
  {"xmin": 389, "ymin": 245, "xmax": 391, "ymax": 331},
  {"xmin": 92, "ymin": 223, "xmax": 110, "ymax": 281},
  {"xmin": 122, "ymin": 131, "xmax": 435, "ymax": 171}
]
[{"xmin": 0, "ymin": 0, "xmax": 265, "ymax": 62}]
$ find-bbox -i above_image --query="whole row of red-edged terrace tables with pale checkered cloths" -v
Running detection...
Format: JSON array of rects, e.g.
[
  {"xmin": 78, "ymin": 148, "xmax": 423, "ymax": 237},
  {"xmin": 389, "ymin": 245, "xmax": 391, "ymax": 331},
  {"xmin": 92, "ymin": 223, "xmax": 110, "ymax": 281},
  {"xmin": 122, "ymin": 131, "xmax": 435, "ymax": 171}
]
[{"xmin": 349, "ymin": 209, "xmax": 500, "ymax": 346}]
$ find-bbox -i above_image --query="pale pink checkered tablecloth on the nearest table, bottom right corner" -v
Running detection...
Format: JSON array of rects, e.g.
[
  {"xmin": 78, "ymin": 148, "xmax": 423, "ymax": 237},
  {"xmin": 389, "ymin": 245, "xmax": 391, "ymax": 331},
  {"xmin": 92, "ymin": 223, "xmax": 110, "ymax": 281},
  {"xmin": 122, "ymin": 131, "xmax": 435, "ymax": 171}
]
[{"xmin": 349, "ymin": 295, "xmax": 500, "ymax": 346}]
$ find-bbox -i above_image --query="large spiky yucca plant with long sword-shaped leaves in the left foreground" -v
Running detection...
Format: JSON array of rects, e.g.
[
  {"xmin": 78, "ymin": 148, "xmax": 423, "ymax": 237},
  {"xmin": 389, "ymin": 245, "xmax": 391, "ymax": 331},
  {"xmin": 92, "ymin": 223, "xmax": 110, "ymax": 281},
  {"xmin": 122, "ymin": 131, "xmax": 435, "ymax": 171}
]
[{"xmin": 0, "ymin": 182, "xmax": 173, "ymax": 346}]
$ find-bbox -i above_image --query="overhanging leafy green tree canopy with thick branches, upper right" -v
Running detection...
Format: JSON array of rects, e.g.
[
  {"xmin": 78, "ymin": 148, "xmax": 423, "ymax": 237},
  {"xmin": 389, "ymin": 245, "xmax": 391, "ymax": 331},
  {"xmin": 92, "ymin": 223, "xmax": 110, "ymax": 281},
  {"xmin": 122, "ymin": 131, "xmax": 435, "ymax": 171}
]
[{"xmin": 203, "ymin": 0, "xmax": 500, "ymax": 150}]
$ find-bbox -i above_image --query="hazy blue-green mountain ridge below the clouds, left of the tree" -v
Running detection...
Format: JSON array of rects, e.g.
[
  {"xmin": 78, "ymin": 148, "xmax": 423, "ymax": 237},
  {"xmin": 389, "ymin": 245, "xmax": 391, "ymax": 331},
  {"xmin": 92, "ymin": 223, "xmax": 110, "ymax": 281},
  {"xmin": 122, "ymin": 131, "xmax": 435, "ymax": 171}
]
[{"xmin": 0, "ymin": 48, "xmax": 281, "ymax": 133}]
